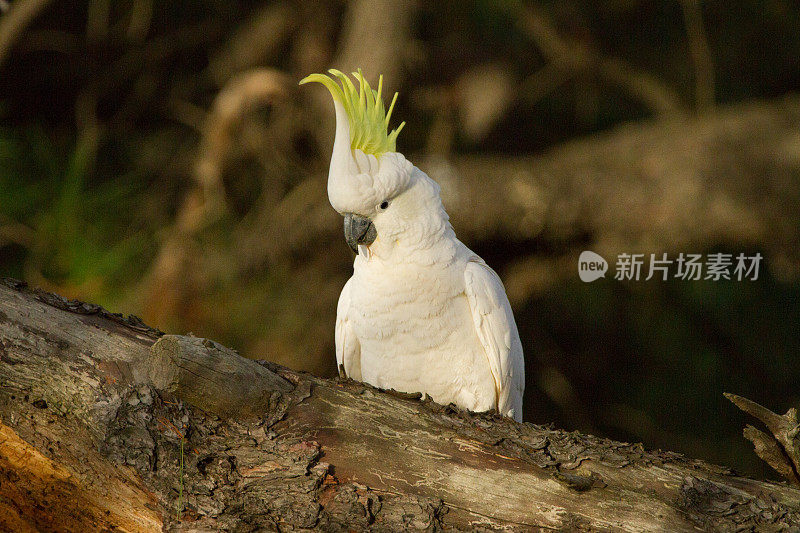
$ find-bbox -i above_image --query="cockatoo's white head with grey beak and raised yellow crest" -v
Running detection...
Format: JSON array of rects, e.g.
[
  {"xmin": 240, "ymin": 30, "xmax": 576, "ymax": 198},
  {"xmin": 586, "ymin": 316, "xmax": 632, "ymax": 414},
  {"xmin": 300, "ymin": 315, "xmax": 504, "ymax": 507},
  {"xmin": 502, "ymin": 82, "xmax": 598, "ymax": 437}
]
[{"xmin": 300, "ymin": 69, "xmax": 447, "ymax": 257}]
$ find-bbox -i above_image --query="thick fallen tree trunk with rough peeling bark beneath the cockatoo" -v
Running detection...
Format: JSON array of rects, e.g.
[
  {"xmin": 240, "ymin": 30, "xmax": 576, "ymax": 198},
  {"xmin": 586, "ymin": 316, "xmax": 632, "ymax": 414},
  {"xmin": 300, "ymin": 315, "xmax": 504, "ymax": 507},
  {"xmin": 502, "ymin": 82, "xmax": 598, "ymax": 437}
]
[{"xmin": 0, "ymin": 281, "xmax": 800, "ymax": 531}]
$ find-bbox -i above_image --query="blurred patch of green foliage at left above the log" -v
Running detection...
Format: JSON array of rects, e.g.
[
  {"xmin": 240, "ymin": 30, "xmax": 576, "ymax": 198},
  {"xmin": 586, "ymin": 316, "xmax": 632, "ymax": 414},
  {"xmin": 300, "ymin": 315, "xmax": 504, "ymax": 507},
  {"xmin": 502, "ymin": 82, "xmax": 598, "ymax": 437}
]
[{"xmin": 0, "ymin": 127, "xmax": 153, "ymax": 298}]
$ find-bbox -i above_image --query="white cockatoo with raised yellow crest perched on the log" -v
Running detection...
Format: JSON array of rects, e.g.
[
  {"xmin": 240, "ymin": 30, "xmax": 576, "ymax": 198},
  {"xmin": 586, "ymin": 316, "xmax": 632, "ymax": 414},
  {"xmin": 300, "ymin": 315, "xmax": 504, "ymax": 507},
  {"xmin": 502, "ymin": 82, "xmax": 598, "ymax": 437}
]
[{"xmin": 300, "ymin": 70, "xmax": 525, "ymax": 421}]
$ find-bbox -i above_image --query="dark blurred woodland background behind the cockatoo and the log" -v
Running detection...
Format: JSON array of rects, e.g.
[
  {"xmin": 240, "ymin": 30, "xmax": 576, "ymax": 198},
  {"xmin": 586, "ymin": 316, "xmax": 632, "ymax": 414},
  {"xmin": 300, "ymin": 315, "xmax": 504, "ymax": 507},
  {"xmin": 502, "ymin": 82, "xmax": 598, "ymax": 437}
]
[{"xmin": 0, "ymin": 0, "xmax": 800, "ymax": 475}]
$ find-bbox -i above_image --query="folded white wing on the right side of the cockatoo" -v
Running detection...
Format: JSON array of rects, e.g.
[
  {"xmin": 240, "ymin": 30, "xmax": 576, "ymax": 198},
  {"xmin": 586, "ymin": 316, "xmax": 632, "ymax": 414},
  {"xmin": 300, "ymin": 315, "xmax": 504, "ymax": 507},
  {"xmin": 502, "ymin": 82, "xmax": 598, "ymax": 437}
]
[{"xmin": 464, "ymin": 256, "xmax": 525, "ymax": 421}]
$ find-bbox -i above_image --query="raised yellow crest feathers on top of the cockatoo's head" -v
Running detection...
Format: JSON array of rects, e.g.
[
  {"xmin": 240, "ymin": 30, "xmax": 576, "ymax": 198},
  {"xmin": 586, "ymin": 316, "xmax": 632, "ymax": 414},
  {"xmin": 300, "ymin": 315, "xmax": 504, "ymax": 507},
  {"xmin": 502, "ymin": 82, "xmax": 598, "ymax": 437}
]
[{"xmin": 300, "ymin": 69, "xmax": 406, "ymax": 157}]
